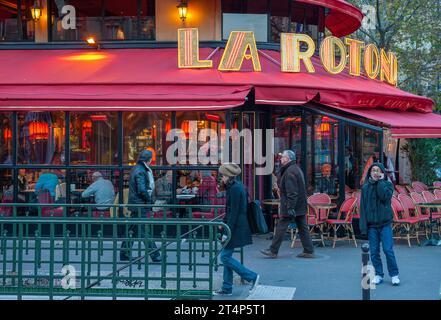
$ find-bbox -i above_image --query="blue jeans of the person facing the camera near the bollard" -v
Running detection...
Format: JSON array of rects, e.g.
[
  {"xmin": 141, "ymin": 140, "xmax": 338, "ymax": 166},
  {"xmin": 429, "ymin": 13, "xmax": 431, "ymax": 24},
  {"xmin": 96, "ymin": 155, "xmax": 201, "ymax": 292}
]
[{"xmin": 368, "ymin": 224, "xmax": 398, "ymax": 277}]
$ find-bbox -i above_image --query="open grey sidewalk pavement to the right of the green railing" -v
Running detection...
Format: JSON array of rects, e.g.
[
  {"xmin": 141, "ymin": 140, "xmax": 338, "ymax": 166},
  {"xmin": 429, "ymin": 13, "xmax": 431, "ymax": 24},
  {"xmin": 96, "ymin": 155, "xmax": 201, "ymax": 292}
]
[{"xmin": 214, "ymin": 235, "xmax": 441, "ymax": 300}]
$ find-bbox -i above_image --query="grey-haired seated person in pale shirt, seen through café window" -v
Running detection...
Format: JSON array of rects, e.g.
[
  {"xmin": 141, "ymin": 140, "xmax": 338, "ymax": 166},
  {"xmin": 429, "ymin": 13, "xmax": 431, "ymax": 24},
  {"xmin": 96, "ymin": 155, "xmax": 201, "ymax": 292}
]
[{"xmin": 81, "ymin": 171, "xmax": 115, "ymax": 211}]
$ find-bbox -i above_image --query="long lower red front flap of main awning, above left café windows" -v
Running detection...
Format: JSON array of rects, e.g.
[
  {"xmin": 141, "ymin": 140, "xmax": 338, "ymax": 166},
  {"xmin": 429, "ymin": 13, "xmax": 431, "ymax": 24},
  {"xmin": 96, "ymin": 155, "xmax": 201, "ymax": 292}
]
[{"xmin": 0, "ymin": 84, "xmax": 251, "ymax": 111}]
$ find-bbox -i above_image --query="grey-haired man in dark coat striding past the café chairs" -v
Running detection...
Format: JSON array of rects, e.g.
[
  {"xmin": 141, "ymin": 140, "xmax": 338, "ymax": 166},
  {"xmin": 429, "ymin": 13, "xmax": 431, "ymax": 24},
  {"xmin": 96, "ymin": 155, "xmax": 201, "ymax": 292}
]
[{"xmin": 260, "ymin": 150, "xmax": 315, "ymax": 259}]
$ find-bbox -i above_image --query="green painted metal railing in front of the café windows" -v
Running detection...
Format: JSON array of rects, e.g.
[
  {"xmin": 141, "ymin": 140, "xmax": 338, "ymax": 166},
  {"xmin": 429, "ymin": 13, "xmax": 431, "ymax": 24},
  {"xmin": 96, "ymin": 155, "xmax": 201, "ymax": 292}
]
[{"xmin": 0, "ymin": 203, "xmax": 235, "ymax": 299}]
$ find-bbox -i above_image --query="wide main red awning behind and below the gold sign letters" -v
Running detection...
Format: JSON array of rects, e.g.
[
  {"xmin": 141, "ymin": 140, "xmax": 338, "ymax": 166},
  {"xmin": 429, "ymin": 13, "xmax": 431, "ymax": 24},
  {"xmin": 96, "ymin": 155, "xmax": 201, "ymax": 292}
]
[{"xmin": 0, "ymin": 48, "xmax": 433, "ymax": 112}]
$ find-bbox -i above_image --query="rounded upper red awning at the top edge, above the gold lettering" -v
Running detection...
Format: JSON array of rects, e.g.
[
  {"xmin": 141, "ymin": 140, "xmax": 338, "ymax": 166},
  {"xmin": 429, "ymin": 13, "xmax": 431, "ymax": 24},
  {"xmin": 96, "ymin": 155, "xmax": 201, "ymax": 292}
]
[{"xmin": 297, "ymin": 0, "xmax": 363, "ymax": 37}]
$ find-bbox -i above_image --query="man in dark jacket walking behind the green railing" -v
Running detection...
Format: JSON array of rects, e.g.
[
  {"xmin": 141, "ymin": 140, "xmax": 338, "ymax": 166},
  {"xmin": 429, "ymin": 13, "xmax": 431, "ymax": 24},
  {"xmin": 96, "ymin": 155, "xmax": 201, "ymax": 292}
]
[{"xmin": 120, "ymin": 150, "xmax": 161, "ymax": 262}]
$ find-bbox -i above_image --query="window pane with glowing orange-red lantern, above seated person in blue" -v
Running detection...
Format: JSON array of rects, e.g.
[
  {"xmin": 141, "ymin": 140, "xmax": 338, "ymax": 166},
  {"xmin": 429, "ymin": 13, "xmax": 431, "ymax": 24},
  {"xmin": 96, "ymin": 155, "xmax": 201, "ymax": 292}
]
[{"xmin": 18, "ymin": 111, "xmax": 65, "ymax": 165}]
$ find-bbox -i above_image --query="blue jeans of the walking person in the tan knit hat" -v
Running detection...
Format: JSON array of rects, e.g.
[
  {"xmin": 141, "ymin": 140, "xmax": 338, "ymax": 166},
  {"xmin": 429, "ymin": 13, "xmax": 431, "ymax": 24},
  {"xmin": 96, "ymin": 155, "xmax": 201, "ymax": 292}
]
[{"xmin": 220, "ymin": 249, "xmax": 257, "ymax": 292}]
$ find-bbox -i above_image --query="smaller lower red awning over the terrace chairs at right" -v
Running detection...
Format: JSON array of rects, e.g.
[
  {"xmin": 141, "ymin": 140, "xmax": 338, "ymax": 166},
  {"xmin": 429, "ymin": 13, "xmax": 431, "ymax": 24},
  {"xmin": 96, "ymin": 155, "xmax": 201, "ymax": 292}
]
[{"xmin": 324, "ymin": 108, "xmax": 441, "ymax": 138}]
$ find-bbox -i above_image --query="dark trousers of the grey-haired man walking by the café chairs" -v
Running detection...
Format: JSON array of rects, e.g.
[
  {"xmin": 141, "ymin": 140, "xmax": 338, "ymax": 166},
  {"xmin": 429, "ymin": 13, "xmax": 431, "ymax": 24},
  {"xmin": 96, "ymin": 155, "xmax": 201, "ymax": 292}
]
[{"xmin": 270, "ymin": 215, "xmax": 314, "ymax": 254}]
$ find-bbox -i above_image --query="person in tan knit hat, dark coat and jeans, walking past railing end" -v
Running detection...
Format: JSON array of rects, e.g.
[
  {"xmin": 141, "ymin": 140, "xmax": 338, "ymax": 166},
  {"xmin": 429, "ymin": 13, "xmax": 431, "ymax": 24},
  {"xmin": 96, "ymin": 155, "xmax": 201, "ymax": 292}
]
[{"xmin": 213, "ymin": 163, "xmax": 259, "ymax": 296}]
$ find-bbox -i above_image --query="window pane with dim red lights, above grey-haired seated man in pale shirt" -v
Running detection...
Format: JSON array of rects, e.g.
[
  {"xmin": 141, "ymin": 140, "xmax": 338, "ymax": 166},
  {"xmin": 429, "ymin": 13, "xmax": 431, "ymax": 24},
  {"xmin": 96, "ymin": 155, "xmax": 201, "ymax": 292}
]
[{"xmin": 70, "ymin": 112, "xmax": 118, "ymax": 165}]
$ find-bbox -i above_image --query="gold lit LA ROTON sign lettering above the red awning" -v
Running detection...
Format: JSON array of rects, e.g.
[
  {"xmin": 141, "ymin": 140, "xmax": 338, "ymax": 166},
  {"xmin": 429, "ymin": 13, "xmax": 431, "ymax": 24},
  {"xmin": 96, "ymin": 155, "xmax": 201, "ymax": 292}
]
[{"xmin": 178, "ymin": 28, "xmax": 398, "ymax": 86}]
